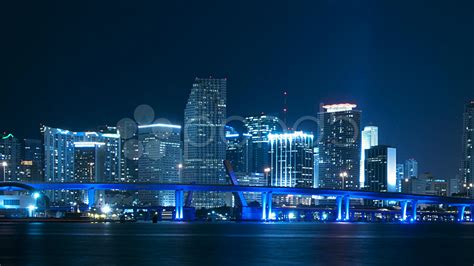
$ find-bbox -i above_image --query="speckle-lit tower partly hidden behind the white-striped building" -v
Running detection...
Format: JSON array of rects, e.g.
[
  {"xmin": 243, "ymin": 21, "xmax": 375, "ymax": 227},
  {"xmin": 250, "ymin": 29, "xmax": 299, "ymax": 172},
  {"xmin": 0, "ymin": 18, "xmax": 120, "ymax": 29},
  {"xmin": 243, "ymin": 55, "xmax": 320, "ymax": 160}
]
[{"xmin": 244, "ymin": 115, "xmax": 282, "ymax": 173}]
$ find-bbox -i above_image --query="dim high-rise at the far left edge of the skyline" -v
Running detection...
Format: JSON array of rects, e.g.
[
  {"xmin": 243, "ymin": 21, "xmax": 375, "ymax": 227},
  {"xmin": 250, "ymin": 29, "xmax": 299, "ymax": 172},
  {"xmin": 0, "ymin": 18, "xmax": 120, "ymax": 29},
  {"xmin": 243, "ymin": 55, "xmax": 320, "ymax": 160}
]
[{"xmin": 0, "ymin": 134, "xmax": 21, "ymax": 181}]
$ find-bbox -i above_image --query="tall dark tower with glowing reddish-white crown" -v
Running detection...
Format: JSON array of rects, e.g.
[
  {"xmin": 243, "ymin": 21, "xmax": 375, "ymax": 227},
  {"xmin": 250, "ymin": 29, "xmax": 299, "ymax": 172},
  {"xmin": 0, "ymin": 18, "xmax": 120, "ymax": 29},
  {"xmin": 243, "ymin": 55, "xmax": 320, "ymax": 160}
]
[{"xmin": 318, "ymin": 103, "xmax": 361, "ymax": 189}]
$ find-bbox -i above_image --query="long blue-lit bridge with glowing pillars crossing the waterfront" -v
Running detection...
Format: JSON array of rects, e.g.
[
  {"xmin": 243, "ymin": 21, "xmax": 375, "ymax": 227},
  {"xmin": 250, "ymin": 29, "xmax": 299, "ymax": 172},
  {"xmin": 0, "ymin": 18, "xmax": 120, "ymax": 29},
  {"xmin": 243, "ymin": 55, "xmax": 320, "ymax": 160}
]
[{"xmin": 0, "ymin": 182, "xmax": 474, "ymax": 221}]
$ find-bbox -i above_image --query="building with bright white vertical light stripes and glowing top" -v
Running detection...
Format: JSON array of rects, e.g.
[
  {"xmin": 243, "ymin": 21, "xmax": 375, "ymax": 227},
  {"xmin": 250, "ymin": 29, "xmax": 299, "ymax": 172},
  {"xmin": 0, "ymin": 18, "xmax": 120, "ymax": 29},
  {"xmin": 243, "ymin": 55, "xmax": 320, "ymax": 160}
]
[{"xmin": 268, "ymin": 131, "xmax": 314, "ymax": 187}]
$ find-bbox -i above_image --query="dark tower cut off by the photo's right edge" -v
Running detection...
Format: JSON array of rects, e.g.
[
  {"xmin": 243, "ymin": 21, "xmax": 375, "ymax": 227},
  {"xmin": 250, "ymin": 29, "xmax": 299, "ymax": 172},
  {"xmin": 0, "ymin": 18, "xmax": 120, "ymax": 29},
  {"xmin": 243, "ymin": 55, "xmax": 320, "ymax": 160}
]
[{"xmin": 460, "ymin": 101, "xmax": 474, "ymax": 198}]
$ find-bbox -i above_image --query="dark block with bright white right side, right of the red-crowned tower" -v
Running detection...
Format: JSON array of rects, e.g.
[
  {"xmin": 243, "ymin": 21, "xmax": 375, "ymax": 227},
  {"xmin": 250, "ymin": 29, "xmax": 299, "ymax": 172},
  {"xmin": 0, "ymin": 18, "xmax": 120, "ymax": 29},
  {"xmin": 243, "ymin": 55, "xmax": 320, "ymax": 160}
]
[{"xmin": 365, "ymin": 145, "xmax": 397, "ymax": 192}]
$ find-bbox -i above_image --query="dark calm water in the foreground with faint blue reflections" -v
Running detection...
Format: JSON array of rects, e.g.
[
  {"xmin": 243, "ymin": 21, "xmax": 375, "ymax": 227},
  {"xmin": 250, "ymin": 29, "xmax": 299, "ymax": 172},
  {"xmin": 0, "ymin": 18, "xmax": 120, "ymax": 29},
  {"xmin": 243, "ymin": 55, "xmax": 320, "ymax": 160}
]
[{"xmin": 0, "ymin": 223, "xmax": 474, "ymax": 266}]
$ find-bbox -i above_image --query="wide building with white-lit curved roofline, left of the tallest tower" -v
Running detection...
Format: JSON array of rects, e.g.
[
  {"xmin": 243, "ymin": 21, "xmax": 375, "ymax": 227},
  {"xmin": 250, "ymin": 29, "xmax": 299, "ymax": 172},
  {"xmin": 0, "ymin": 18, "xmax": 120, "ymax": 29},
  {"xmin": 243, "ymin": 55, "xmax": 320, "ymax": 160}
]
[{"xmin": 138, "ymin": 123, "xmax": 182, "ymax": 206}]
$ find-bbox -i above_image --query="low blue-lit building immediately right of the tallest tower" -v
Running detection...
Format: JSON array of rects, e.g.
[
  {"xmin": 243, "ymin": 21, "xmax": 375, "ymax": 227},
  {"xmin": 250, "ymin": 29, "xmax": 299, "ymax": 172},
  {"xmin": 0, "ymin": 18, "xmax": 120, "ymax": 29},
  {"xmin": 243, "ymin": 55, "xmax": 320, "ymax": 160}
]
[{"xmin": 225, "ymin": 126, "xmax": 252, "ymax": 174}]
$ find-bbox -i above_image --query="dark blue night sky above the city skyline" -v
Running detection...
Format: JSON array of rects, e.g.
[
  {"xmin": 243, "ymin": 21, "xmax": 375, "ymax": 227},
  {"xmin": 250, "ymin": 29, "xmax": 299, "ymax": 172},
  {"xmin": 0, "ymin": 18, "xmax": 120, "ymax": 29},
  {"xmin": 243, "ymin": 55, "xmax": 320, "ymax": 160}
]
[{"xmin": 0, "ymin": 0, "xmax": 474, "ymax": 177}]
